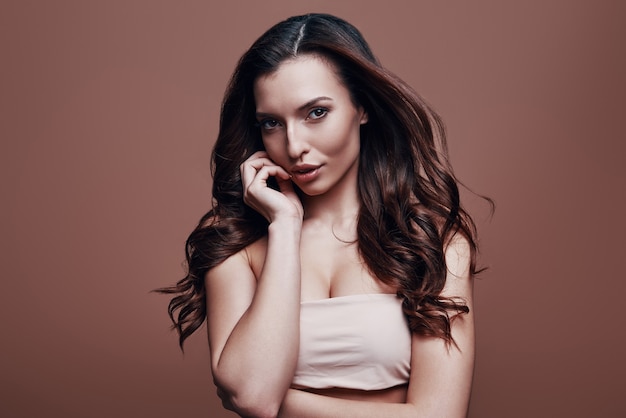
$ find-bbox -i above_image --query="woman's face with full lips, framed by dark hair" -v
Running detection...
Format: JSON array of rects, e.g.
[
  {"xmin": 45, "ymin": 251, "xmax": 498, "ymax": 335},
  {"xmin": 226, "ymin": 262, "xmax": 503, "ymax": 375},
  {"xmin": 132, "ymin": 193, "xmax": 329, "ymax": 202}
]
[{"xmin": 254, "ymin": 55, "xmax": 367, "ymax": 196}]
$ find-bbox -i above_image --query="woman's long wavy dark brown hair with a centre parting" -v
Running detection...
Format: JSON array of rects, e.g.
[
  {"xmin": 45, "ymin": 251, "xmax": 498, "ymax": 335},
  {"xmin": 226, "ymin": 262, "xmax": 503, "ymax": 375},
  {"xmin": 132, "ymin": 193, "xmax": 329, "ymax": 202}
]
[{"xmin": 158, "ymin": 14, "xmax": 476, "ymax": 347}]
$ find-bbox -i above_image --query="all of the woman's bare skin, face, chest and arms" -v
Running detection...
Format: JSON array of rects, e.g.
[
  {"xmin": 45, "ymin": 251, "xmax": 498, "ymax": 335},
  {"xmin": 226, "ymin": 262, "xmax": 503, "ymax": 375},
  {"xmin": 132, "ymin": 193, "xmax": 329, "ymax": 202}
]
[{"xmin": 206, "ymin": 56, "xmax": 474, "ymax": 418}]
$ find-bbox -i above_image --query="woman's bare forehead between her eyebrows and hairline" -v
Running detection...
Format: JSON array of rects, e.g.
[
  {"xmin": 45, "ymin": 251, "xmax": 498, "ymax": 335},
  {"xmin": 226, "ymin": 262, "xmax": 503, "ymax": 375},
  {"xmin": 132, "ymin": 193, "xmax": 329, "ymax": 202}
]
[{"xmin": 254, "ymin": 55, "xmax": 349, "ymax": 111}]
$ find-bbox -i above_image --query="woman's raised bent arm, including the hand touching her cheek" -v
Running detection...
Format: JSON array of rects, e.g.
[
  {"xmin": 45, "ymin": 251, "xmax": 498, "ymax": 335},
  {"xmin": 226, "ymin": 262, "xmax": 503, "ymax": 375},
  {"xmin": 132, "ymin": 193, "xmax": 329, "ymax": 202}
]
[{"xmin": 206, "ymin": 153, "xmax": 302, "ymax": 417}]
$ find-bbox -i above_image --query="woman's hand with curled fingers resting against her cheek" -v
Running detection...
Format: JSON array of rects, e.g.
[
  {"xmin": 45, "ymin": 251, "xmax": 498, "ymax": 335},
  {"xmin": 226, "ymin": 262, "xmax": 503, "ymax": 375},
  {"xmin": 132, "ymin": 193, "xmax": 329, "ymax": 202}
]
[{"xmin": 240, "ymin": 151, "xmax": 304, "ymax": 223}]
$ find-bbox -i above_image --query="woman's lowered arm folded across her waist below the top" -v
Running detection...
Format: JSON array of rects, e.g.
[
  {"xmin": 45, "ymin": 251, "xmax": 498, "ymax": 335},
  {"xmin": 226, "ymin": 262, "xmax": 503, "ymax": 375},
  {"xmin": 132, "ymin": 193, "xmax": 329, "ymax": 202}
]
[{"xmin": 279, "ymin": 237, "xmax": 474, "ymax": 418}]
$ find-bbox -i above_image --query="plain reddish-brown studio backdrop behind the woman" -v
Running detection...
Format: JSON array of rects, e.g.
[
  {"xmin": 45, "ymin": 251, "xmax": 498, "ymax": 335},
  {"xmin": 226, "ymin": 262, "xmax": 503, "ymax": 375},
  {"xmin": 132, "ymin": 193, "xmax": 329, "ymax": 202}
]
[{"xmin": 0, "ymin": 0, "xmax": 626, "ymax": 418}]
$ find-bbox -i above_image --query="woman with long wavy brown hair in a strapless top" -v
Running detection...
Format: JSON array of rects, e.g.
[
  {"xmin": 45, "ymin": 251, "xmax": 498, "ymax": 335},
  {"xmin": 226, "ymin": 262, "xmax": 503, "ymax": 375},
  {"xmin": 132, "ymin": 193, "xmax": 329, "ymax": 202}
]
[{"xmin": 161, "ymin": 14, "xmax": 476, "ymax": 417}]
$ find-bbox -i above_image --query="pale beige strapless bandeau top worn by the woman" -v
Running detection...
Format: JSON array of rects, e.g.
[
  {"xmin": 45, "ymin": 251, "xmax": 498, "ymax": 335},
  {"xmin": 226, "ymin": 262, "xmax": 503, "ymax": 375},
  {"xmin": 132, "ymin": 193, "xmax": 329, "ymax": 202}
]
[{"xmin": 292, "ymin": 294, "xmax": 411, "ymax": 390}]
